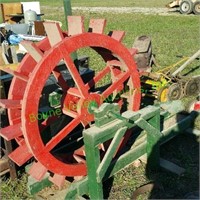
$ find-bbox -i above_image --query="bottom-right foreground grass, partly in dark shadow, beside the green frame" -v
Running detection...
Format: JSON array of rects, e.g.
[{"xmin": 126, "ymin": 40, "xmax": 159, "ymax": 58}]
[{"xmin": 109, "ymin": 135, "xmax": 199, "ymax": 200}]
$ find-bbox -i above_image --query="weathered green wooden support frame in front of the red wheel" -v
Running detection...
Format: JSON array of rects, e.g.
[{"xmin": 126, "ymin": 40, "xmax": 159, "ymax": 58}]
[{"xmin": 65, "ymin": 101, "xmax": 200, "ymax": 199}]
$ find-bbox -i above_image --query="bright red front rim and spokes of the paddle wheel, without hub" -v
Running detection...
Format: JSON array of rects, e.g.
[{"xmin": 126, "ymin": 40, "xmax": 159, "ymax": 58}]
[{"xmin": 22, "ymin": 33, "xmax": 139, "ymax": 176}]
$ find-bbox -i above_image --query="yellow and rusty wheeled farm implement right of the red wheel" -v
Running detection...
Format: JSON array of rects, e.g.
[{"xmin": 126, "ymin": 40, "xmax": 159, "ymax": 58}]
[{"xmin": 140, "ymin": 50, "xmax": 200, "ymax": 102}]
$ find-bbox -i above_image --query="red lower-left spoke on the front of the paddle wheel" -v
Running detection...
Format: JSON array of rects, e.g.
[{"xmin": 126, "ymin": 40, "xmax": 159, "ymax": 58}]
[{"xmin": 45, "ymin": 116, "xmax": 80, "ymax": 151}]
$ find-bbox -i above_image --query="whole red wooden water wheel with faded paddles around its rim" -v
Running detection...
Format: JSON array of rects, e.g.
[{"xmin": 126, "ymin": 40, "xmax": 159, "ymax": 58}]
[{"xmin": 0, "ymin": 16, "xmax": 141, "ymax": 185}]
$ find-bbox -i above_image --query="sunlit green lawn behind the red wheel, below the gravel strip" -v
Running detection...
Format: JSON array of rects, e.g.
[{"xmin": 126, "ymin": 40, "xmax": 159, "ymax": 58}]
[{"xmin": 39, "ymin": 8, "xmax": 200, "ymax": 75}]
